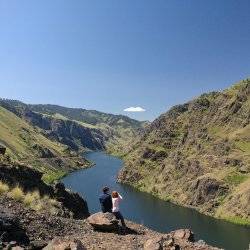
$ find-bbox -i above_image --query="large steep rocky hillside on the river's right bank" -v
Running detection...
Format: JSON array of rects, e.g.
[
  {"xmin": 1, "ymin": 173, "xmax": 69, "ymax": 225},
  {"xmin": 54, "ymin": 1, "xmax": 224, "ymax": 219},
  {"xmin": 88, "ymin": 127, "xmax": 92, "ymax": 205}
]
[{"xmin": 118, "ymin": 79, "xmax": 250, "ymax": 224}]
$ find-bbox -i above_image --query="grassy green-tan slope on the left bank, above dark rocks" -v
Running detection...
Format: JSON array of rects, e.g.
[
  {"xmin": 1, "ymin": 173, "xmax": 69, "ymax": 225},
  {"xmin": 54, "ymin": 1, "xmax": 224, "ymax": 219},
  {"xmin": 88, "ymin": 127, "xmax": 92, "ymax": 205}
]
[{"xmin": 0, "ymin": 106, "xmax": 87, "ymax": 180}]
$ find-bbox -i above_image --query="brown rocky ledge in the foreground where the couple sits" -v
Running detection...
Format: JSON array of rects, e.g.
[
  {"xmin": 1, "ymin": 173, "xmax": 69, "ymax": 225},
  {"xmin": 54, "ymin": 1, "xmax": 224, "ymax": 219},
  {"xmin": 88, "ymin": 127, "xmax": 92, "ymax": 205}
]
[{"xmin": 0, "ymin": 196, "xmax": 221, "ymax": 250}]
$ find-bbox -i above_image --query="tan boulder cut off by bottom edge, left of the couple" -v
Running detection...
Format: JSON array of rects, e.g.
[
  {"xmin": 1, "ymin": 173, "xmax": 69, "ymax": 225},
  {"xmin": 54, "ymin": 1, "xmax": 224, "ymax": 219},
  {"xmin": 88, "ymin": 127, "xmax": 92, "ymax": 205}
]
[{"xmin": 43, "ymin": 238, "xmax": 87, "ymax": 250}]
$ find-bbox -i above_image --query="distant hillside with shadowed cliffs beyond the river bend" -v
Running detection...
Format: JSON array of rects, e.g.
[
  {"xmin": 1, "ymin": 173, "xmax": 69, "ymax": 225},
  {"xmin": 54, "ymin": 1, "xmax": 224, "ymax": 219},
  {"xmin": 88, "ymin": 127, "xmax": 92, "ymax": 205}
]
[{"xmin": 0, "ymin": 99, "xmax": 144, "ymax": 153}]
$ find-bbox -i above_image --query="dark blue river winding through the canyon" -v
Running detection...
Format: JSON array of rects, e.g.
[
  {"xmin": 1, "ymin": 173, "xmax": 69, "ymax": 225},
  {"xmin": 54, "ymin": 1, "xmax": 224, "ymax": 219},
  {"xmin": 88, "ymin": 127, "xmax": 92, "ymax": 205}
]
[{"xmin": 62, "ymin": 152, "xmax": 250, "ymax": 250}]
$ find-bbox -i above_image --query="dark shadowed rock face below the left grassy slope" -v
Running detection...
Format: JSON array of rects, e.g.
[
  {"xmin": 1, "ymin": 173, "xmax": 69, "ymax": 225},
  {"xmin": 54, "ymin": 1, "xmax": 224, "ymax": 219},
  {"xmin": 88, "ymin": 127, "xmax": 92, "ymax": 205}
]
[{"xmin": 0, "ymin": 165, "xmax": 89, "ymax": 219}]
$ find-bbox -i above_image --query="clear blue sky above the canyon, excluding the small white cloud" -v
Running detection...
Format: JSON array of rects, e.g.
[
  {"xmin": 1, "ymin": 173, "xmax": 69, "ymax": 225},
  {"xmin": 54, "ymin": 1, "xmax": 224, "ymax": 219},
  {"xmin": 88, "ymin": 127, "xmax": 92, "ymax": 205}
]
[{"xmin": 0, "ymin": 0, "xmax": 250, "ymax": 120}]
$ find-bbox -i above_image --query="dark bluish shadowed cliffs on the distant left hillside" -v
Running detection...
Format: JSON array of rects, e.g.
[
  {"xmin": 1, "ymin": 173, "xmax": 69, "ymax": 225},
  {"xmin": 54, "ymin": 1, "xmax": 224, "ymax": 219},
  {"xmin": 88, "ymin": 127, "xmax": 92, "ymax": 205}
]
[{"xmin": 0, "ymin": 100, "xmax": 104, "ymax": 151}]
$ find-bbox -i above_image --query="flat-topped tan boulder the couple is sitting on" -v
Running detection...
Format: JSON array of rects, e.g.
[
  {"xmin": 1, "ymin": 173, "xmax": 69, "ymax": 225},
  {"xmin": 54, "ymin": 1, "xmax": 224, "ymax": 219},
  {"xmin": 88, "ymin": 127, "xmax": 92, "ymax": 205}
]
[{"xmin": 87, "ymin": 212, "xmax": 118, "ymax": 232}]
